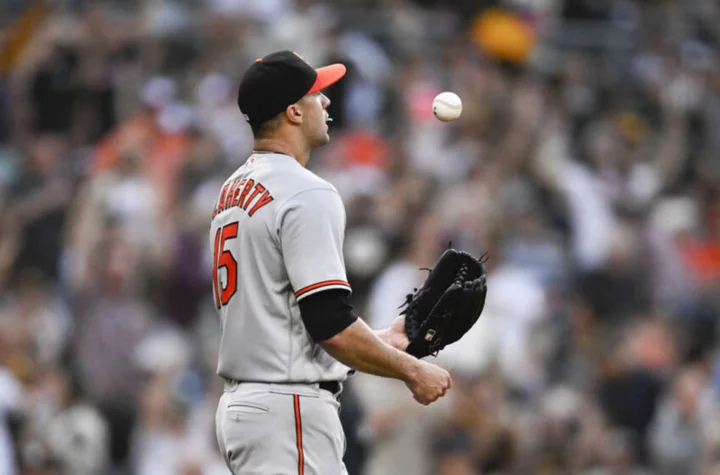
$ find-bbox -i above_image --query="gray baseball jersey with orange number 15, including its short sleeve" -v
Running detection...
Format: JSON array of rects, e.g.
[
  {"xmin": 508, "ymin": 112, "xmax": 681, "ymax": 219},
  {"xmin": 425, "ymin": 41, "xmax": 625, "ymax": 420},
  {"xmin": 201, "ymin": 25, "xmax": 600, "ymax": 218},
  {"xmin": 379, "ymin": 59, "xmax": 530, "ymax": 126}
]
[{"xmin": 210, "ymin": 153, "xmax": 350, "ymax": 383}]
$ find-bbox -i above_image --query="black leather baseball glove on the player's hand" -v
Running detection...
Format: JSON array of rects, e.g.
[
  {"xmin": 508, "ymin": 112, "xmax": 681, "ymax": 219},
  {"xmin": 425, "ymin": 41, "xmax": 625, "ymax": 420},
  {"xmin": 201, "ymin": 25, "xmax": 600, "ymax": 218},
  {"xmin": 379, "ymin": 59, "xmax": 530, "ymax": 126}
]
[{"xmin": 401, "ymin": 249, "xmax": 487, "ymax": 358}]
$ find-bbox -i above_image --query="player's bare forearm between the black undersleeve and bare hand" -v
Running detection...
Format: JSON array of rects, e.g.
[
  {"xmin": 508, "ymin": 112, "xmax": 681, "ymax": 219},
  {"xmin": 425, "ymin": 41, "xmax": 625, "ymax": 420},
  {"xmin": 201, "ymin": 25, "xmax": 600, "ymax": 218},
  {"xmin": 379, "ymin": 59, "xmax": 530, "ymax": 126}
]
[{"xmin": 321, "ymin": 319, "xmax": 418, "ymax": 381}]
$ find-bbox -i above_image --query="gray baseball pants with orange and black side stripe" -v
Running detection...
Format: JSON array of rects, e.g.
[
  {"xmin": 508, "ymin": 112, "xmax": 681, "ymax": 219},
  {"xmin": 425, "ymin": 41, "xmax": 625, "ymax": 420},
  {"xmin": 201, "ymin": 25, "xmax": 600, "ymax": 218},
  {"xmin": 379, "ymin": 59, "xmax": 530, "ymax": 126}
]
[{"xmin": 215, "ymin": 381, "xmax": 347, "ymax": 475}]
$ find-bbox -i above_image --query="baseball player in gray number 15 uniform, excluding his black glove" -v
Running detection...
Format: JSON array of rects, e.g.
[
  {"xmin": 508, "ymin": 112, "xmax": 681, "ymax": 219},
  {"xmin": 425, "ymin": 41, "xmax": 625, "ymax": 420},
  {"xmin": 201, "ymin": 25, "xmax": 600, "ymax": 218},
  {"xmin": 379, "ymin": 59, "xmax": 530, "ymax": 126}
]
[{"xmin": 210, "ymin": 51, "xmax": 451, "ymax": 475}]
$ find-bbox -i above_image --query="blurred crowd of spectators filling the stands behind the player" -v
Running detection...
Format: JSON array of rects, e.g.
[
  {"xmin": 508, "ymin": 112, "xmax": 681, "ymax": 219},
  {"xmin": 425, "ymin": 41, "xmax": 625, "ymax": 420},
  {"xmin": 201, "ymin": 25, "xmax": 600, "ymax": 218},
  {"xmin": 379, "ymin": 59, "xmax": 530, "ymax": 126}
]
[{"xmin": 0, "ymin": 0, "xmax": 720, "ymax": 475}]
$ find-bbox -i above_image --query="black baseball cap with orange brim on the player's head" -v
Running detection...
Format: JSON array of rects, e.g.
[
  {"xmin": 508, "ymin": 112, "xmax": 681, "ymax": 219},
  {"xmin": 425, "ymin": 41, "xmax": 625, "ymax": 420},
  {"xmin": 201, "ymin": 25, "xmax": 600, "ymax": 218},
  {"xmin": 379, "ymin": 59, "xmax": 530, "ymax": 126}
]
[{"xmin": 238, "ymin": 51, "xmax": 346, "ymax": 130}]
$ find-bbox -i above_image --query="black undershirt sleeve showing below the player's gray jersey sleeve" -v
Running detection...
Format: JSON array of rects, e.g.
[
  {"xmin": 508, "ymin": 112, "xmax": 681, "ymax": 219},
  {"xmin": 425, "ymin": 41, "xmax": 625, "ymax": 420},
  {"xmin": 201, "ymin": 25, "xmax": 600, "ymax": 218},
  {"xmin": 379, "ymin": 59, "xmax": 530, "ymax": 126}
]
[{"xmin": 298, "ymin": 289, "xmax": 358, "ymax": 343}]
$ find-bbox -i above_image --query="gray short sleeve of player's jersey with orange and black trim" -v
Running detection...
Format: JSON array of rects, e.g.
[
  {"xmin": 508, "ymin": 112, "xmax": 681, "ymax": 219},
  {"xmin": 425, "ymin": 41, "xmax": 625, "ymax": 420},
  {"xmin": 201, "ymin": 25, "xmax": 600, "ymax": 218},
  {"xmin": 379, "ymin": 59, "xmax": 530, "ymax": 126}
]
[{"xmin": 277, "ymin": 188, "xmax": 351, "ymax": 300}]
